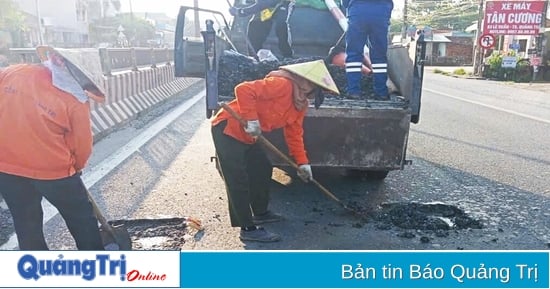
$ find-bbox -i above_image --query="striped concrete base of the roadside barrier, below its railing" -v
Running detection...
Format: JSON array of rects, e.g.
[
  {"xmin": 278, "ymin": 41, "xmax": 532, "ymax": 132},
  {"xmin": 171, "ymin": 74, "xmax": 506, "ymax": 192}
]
[{"xmin": 91, "ymin": 65, "xmax": 200, "ymax": 140}]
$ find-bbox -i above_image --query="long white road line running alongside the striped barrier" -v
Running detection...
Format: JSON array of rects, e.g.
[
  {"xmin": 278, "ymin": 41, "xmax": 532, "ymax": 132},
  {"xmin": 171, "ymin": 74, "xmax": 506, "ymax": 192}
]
[{"xmin": 0, "ymin": 90, "xmax": 206, "ymax": 250}]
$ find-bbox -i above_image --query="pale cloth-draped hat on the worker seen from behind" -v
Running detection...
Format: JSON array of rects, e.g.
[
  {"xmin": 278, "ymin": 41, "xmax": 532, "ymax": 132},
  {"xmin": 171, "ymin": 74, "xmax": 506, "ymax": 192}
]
[{"xmin": 36, "ymin": 45, "xmax": 105, "ymax": 102}]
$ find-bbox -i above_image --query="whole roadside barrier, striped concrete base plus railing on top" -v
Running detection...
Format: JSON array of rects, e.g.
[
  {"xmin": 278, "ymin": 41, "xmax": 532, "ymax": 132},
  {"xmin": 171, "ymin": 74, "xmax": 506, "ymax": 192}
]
[{"xmin": 10, "ymin": 48, "xmax": 201, "ymax": 141}]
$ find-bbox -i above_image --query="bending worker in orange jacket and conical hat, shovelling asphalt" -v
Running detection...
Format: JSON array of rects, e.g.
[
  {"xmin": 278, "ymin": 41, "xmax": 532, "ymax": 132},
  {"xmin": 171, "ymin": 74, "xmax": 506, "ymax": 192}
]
[{"xmin": 212, "ymin": 60, "xmax": 339, "ymax": 242}]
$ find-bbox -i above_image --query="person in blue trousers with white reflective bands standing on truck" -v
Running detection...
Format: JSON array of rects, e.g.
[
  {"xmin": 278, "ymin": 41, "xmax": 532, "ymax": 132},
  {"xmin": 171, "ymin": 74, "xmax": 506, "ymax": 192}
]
[{"xmin": 342, "ymin": 0, "xmax": 393, "ymax": 100}]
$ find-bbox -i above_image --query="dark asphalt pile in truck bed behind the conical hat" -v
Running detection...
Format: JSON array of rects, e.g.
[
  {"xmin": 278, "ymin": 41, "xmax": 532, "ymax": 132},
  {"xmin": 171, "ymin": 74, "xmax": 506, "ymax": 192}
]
[{"xmin": 218, "ymin": 50, "xmax": 372, "ymax": 99}]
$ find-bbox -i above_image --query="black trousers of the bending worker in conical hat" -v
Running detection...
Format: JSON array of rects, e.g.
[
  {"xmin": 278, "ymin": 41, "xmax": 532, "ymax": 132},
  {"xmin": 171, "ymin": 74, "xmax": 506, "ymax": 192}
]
[{"xmin": 212, "ymin": 121, "xmax": 273, "ymax": 227}]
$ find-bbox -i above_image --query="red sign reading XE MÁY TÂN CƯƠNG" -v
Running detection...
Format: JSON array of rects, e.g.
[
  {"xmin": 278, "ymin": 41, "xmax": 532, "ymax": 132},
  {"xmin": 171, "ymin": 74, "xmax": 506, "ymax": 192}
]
[{"xmin": 483, "ymin": 1, "xmax": 546, "ymax": 35}]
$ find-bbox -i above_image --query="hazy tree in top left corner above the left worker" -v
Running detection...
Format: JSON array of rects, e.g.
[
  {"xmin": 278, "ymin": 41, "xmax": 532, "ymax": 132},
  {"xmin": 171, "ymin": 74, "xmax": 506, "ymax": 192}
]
[{"xmin": 0, "ymin": 0, "xmax": 25, "ymax": 49}]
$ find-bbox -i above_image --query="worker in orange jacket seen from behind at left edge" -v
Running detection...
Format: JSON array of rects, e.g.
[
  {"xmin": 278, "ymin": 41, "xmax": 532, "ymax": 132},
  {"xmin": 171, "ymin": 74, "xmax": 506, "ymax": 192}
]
[{"xmin": 0, "ymin": 46, "xmax": 105, "ymax": 250}]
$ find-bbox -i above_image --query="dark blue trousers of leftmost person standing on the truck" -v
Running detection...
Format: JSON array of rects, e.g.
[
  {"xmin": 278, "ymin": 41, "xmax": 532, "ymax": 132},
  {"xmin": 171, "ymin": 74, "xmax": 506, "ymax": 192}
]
[{"xmin": 248, "ymin": 4, "xmax": 294, "ymax": 58}]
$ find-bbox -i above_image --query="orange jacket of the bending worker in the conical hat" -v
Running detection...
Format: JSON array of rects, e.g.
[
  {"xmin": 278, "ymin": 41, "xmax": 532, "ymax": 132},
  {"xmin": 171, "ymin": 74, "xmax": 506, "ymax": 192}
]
[{"xmin": 212, "ymin": 77, "xmax": 309, "ymax": 164}]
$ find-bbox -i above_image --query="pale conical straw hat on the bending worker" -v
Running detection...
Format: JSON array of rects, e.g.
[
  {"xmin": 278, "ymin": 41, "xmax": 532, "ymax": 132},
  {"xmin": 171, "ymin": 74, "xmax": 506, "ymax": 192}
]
[{"xmin": 281, "ymin": 60, "xmax": 340, "ymax": 94}]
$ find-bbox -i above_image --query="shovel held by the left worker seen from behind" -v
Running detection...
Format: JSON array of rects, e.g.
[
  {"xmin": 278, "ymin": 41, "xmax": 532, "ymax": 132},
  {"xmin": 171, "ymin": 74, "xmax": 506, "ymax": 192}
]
[{"xmin": 86, "ymin": 191, "xmax": 132, "ymax": 251}]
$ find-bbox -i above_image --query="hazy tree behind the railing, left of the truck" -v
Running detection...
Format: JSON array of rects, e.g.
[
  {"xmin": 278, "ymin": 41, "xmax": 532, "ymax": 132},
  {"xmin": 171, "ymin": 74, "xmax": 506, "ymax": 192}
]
[{"xmin": 89, "ymin": 14, "xmax": 155, "ymax": 47}]
